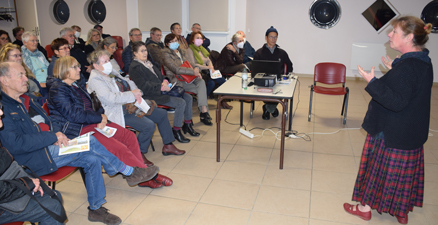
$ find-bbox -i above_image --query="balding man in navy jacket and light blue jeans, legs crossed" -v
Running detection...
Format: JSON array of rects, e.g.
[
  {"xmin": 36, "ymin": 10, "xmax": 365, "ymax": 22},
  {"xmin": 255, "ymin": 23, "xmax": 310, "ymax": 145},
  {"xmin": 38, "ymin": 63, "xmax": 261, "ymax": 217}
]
[{"xmin": 0, "ymin": 62, "xmax": 158, "ymax": 224}]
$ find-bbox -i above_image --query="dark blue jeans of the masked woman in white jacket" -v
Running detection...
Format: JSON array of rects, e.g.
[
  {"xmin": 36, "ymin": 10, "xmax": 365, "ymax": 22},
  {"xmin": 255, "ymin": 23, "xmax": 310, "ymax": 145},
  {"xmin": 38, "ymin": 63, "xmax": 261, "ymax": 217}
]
[{"xmin": 125, "ymin": 108, "xmax": 175, "ymax": 153}]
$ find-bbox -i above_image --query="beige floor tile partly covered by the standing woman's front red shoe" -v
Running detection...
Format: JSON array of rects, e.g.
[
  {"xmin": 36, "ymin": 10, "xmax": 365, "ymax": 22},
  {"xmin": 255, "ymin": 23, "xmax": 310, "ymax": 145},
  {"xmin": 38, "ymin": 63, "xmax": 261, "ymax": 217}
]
[{"xmin": 310, "ymin": 191, "xmax": 368, "ymax": 224}]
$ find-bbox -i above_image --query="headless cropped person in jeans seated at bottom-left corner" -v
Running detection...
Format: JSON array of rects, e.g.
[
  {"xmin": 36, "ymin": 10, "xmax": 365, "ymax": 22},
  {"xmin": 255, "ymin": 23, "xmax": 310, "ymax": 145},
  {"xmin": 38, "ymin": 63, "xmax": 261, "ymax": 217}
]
[{"xmin": 0, "ymin": 111, "xmax": 64, "ymax": 225}]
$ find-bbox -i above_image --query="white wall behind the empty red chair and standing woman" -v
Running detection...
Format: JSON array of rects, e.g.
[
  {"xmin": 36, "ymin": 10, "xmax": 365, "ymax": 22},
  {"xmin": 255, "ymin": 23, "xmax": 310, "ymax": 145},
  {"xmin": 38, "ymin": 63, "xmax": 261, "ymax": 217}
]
[{"xmin": 246, "ymin": 0, "xmax": 438, "ymax": 82}]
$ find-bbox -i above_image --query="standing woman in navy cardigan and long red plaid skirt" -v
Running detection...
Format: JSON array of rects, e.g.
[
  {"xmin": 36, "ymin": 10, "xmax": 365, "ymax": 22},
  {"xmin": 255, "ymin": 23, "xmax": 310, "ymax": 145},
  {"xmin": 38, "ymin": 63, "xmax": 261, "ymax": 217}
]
[{"xmin": 344, "ymin": 16, "xmax": 433, "ymax": 224}]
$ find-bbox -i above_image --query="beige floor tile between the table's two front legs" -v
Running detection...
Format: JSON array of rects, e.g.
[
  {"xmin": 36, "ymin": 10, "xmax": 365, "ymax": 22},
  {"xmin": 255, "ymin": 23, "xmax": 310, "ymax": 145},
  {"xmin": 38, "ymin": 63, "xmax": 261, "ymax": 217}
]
[{"xmin": 227, "ymin": 145, "xmax": 272, "ymax": 165}]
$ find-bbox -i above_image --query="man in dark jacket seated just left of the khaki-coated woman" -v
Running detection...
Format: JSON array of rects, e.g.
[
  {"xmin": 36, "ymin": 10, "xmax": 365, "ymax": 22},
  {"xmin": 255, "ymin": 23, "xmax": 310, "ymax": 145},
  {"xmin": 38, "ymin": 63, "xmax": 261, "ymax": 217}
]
[{"xmin": 146, "ymin": 27, "xmax": 164, "ymax": 68}]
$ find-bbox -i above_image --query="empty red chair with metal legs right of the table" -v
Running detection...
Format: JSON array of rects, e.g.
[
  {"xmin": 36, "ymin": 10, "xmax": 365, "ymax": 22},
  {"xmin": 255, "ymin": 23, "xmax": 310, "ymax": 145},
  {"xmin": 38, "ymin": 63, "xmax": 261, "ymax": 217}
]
[{"xmin": 309, "ymin": 62, "xmax": 349, "ymax": 124}]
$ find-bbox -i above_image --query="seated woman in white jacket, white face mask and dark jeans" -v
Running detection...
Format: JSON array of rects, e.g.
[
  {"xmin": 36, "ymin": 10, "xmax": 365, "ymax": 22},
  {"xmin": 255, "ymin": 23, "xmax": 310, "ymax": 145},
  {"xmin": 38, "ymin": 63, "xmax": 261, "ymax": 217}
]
[{"xmin": 87, "ymin": 50, "xmax": 185, "ymax": 161}]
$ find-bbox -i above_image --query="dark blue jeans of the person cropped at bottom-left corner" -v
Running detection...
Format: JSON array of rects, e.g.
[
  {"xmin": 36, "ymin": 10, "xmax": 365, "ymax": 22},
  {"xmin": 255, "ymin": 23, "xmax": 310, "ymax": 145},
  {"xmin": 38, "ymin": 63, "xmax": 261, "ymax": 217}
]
[{"xmin": 0, "ymin": 190, "xmax": 64, "ymax": 225}]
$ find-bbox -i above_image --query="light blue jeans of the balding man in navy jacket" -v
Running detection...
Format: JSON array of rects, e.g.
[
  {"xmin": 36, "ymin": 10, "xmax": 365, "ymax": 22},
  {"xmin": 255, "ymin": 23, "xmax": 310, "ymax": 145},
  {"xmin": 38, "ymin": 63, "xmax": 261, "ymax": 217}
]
[{"xmin": 49, "ymin": 136, "xmax": 125, "ymax": 210}]
